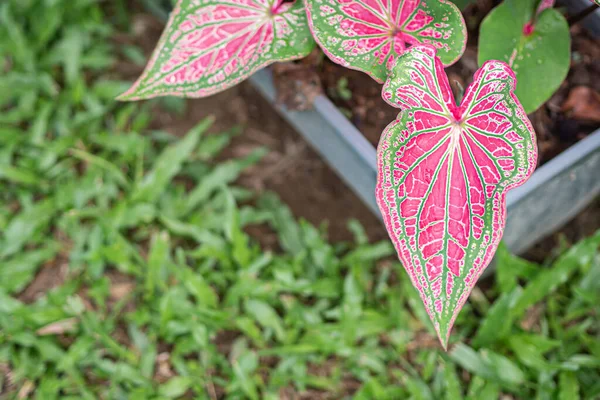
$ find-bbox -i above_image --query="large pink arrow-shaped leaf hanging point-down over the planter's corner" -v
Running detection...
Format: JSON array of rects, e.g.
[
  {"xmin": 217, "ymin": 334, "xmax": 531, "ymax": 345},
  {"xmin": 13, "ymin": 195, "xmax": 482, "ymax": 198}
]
[{"xmin": 376, "ymin": 45, "xmax": 537, "ymax": 348}]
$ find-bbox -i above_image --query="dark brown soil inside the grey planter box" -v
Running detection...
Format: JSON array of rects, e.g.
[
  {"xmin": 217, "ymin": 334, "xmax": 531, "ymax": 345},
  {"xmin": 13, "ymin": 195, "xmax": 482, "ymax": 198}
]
[{"xmin": 316, "ymin": 0, "xmax": 600, "ymax": 164}]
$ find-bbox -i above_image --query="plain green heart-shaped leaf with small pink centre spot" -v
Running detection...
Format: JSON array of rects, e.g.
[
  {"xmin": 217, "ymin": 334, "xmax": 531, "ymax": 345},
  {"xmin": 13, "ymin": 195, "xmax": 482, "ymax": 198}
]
[{"xmin": 478, "ymin": 0, "xmax": 571, "ymax": 113}]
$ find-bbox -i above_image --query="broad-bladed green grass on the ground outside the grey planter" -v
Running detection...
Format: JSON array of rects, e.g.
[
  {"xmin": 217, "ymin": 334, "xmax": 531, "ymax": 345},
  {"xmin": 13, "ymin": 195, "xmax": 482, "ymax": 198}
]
[{"xmin": 0, "ymin": 0, "xmax": 600, "ymax": 400}]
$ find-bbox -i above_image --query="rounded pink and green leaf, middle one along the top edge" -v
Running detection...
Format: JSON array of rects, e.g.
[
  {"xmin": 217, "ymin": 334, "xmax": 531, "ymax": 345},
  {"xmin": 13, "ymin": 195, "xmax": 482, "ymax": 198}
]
[{"xmin": 306, "ymin": 0, "xmax": 467, "ymax": 83}]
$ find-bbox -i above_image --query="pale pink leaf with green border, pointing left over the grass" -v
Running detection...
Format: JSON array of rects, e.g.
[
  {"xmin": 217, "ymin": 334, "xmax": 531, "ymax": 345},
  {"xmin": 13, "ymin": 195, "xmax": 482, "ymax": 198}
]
[{"xmin": 119, "ymin": 0, "xmax": 315, "ymax": 100}]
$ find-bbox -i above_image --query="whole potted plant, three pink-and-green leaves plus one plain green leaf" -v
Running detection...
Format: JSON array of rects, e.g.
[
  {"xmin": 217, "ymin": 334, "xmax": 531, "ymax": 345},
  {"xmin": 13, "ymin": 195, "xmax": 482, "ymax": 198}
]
[{"xmin": 121, "ymin": 0, "xmax": 600, "ymax": 346}]
